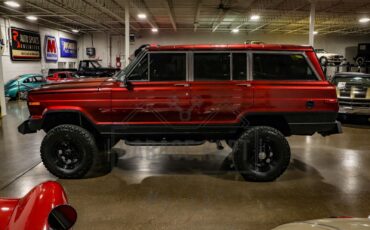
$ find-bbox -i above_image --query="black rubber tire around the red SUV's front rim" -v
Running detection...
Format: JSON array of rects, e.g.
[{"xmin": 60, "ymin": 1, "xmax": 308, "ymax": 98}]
[{"xmin": 40, "ymin": 124, "xmax": 98, "ymax": 179}]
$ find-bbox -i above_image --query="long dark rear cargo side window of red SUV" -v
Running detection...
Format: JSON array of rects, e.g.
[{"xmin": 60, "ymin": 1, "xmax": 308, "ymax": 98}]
[{"xmin": 253, "ymin": 53, "xmax": 317, "ymax": 80}]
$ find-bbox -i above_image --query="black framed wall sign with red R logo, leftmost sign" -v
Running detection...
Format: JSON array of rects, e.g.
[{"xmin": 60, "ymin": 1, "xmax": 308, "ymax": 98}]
[{"xmin": 10, "ymin": 27, "xmax": 41, "ymax": 61}]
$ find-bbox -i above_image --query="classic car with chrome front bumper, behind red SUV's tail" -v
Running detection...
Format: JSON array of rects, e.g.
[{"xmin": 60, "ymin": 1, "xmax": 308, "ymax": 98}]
[{"xmin": 331, "ymin": 72, "xmax": 370, "ymax": 117}]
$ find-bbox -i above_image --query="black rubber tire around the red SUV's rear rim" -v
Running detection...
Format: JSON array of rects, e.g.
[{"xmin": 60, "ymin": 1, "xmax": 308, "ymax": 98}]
[{"xmin": 232, "ymin": 126, "xmax": 291, "ymax": 182}]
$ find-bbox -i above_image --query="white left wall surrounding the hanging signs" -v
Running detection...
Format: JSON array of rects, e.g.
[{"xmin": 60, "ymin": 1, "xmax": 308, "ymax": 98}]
[{"xmin": 0, "ymin": 18, "xmax": 78, "ymax": 82}]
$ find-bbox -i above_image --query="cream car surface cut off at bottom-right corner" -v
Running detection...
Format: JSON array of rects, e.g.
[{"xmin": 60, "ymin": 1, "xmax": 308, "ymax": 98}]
[{"xmin": 273, "ymin": 216, "xmax": 370, "ymax": 230}]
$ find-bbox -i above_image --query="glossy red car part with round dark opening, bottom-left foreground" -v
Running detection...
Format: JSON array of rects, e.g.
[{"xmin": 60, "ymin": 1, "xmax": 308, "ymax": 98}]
[{"xmin": 0, "ymin": 181, "xmax": 77, "ymax": 230}]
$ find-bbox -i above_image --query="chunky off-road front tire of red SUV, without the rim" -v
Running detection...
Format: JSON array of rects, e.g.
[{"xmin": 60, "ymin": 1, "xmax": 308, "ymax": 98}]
[{"xmin": 40, "ymin": 124, "xmax": 98, "ymax": 179}]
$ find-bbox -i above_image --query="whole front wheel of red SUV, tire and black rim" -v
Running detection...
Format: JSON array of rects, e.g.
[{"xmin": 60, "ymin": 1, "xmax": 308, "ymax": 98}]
[{"xmin": 41, "ymin": 125, "xmax": 98, "ymax": 179}]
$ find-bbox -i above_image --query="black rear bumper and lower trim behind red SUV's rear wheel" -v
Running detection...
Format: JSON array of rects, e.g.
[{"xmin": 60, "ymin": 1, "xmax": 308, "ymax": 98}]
[{"xmin": 289, "ymin": 121, "xmax": 343, "ymax": 136}]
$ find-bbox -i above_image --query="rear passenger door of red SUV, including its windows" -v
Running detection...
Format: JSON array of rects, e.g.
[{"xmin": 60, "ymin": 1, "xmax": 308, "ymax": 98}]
[{"xmin": 190, "ymin": 51, "xmax": 253, "ymax": 125}]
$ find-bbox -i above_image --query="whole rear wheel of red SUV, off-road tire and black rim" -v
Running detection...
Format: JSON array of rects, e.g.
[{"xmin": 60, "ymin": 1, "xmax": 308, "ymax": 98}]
[{"xmin": 232, "ymin": 126, "xmax": 290, "ymax": 182}]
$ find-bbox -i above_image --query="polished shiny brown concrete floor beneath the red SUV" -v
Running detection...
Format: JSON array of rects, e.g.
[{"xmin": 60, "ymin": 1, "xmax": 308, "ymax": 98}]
[{"xmin": 0, "ymin": 102, "xmax": 370, "ymax": 229}]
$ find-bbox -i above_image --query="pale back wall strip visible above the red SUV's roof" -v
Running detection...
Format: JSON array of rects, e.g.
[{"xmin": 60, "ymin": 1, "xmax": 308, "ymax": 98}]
[{"xmin": 80, "ymin": 30, "xmax": 370, "ymax": 66}]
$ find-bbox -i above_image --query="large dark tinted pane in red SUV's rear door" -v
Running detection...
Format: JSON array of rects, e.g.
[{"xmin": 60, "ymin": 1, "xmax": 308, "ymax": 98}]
[{"xmin": 194, "ymin": 53, "xmax": 230, "ymax": 81}]
